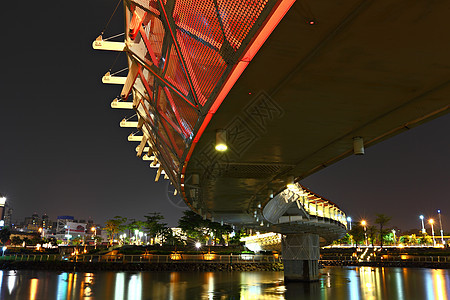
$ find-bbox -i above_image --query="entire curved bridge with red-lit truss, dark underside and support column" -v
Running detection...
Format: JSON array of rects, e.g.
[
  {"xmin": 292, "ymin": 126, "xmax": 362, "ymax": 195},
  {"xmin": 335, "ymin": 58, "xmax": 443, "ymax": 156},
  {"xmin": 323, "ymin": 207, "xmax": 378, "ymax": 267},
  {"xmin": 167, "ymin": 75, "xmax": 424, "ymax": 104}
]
[{"xmin": 93, "ymin": 0, "xmax": 450, "ymax": 280}]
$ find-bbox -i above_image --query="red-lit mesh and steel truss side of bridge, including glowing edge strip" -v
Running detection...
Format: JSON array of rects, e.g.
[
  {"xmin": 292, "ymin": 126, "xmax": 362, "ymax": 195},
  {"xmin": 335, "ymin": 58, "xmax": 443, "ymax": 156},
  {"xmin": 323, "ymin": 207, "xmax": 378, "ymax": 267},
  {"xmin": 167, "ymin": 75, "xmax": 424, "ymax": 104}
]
[{"xmin": 122, "ymin": 0, "xmax": 295, "ymax": 192}]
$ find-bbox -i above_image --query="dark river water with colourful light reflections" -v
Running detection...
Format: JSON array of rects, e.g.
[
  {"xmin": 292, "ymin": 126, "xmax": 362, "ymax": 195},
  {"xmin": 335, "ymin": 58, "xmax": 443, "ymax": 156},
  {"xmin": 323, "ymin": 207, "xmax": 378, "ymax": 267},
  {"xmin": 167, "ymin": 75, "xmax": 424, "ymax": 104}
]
[{"xmin": 0, "ymin": 267, "xmax": 450, "ymax": 300}]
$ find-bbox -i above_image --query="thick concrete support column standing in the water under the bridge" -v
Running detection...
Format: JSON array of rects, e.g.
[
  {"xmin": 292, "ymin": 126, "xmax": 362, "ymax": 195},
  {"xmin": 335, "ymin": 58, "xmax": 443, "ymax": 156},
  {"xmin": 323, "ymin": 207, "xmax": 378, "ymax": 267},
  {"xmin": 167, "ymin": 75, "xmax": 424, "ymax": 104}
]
[{"xmin": 281, "ymin": 233, "xmax": 320, "ymax": 281}]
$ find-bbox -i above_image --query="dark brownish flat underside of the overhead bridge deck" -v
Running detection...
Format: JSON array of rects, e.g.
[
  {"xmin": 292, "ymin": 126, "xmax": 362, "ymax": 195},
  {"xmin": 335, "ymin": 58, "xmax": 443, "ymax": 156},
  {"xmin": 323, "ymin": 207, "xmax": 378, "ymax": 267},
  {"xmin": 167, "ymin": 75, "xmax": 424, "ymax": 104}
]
[{"xmin": 185, "ymin": 0, "xmax": 450, "ymax": 224}]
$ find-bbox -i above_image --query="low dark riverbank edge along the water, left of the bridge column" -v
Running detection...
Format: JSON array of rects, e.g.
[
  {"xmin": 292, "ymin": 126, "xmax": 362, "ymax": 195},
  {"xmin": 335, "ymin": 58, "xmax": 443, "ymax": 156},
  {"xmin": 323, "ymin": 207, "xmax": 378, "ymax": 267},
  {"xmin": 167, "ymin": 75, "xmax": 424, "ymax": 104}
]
[{"xmin": 0, "ymin": 260, "xmax": 284, "ymax": 272}]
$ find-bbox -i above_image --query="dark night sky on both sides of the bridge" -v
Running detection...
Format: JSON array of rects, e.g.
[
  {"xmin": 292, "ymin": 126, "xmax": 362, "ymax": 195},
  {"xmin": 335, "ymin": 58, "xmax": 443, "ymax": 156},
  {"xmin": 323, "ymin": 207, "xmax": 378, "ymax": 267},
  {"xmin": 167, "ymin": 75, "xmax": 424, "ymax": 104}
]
[{"xmin": 0, "ymin": 0, "xmax": 450, "ymax": 230}]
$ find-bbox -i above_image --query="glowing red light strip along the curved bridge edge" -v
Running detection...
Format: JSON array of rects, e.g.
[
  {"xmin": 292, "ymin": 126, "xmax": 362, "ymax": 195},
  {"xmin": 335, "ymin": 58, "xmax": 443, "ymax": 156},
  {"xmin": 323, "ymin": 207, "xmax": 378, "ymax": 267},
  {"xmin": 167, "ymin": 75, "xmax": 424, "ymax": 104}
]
[{"xmin": 181, "ymin": 0, "xmax": 295, "ymax": 173}]
